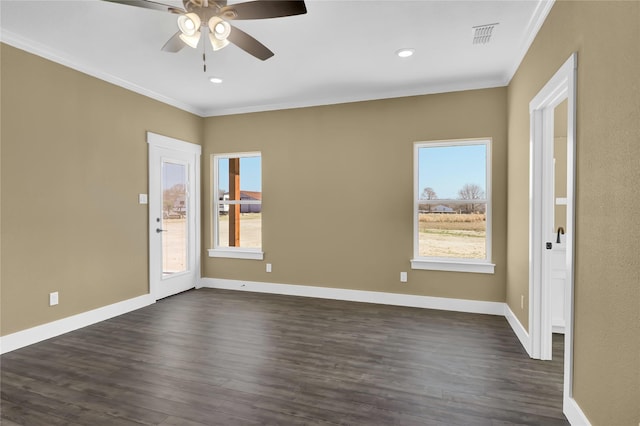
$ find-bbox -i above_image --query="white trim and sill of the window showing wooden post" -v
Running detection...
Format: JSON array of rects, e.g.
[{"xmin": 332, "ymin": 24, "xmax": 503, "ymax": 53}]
[{"xmin": 207, "ymin": 151, "xmax": 264, "ymax": 260}]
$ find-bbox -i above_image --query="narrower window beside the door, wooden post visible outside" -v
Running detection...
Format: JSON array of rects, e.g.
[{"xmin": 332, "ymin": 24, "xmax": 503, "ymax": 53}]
[{"xmin": 209, "ymin": 152, "xmax": 263, "ymax": 260}]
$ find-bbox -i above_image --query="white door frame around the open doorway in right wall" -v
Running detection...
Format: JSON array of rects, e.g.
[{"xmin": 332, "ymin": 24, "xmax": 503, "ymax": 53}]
[{"xmin": 529, "ymin": 53, "xmax": 577, "ymax": 398}]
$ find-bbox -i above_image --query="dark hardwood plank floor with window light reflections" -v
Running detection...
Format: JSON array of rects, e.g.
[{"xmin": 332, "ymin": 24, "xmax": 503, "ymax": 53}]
[{"xmin": 0, "ymin": 289, "xmax": 568, "ymax": 426}]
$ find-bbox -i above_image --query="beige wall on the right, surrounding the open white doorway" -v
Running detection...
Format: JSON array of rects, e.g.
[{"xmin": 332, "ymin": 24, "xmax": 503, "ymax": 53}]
[{"xmin": 507, "ymin": 1, "xmax": 640, "ymax": 426}]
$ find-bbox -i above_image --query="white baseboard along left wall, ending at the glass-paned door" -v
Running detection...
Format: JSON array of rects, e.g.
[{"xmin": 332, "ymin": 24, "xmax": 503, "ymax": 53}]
[{"xmin": 0, "ymin": 294, "xmax": 155, "ymax": 354}]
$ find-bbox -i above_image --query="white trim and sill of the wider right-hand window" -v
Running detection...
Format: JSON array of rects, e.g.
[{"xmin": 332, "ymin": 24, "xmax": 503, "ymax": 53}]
[{"xmin": 411, "ymin": 138, "xmax": 495, "ymax": 274}]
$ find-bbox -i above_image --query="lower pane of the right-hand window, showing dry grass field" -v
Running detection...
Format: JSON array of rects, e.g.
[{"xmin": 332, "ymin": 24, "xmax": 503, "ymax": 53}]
[{"xmin": 418, "ymin": 206, "xmax": 487, "ymax": 259}]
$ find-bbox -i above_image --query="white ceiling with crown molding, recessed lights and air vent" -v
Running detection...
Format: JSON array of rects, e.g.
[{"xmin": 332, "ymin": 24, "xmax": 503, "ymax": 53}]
[{"xmin": 0, "ymin": 0, "xmax": 552, "ymax": 116}]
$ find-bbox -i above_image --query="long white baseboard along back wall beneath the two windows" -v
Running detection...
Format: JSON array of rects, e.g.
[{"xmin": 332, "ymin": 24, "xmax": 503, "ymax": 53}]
[{"xmin": 198, "ymin": 278, "xmax": 504, "ymax": 316}]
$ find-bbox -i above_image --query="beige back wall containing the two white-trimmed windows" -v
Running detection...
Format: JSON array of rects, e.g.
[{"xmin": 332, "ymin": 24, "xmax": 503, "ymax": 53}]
[{"xmin": 203, "ymin": 88, "xmax": 507, "ymax": 302}]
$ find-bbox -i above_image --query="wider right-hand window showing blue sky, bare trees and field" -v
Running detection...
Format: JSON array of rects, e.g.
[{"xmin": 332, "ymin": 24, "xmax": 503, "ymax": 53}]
[{"xmin": 411, "ymin": 139, "xmax": 495, "ymax": 273}]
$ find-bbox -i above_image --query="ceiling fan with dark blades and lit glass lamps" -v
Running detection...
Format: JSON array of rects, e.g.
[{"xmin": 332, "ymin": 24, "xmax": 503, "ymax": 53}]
[{"xmin": 104, "ymin": 0, "xmax": 307, "ymax": 61}]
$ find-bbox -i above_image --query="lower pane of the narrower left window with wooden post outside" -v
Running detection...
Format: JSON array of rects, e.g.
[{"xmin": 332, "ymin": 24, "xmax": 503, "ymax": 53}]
[{"xmin": 218, "ymin": 208, "xmax": 262, "ymax": 248}]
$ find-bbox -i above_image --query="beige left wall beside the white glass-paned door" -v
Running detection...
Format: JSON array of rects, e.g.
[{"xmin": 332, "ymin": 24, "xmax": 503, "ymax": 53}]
[{"xmin": 0, "ymin": 45, "xmax": 202, "ymax": 335}]
